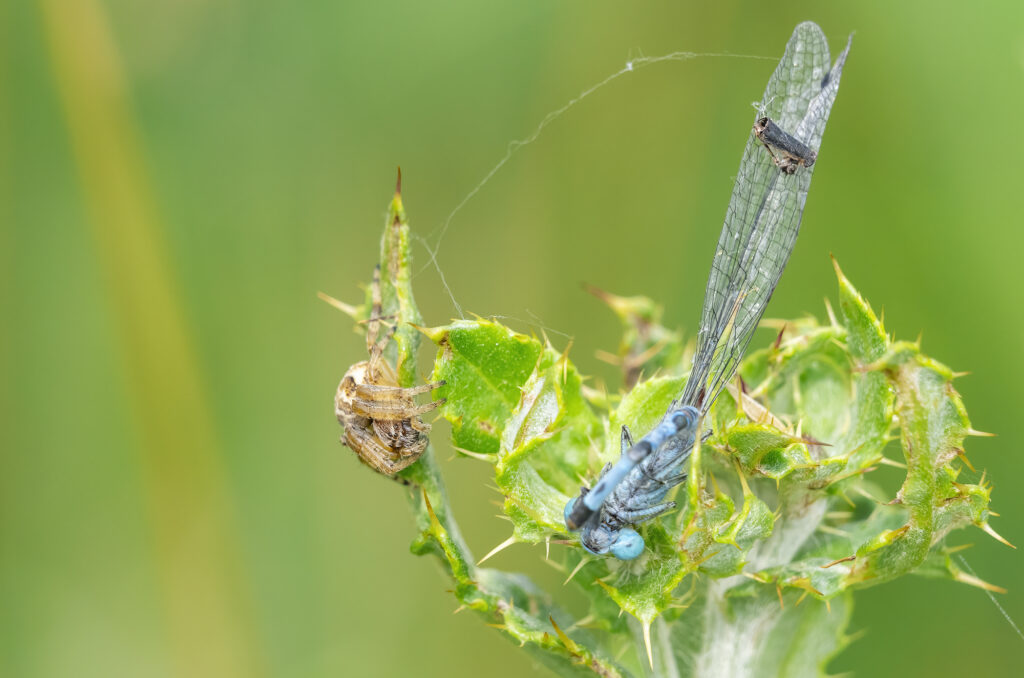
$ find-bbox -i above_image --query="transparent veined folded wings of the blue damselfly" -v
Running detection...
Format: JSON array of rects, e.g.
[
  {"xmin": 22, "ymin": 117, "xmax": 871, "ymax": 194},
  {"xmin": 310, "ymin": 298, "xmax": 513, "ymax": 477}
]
[{"xmin": 680, "ymin": 23, "xmax": 850, "ymax": 412}]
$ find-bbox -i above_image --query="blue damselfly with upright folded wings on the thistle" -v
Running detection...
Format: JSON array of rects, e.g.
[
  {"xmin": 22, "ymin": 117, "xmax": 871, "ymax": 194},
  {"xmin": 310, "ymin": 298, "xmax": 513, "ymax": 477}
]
[{"xmin": 565, "ymin": 22, "xmax": 852, "ymax": 560}]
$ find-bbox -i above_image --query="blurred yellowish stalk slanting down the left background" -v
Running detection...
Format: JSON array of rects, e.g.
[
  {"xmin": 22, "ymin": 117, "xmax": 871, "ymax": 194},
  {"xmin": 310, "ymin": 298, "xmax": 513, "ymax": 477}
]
[{"xmin": 40, "ymin": 0, "xmax": 265, "ymax": 678}]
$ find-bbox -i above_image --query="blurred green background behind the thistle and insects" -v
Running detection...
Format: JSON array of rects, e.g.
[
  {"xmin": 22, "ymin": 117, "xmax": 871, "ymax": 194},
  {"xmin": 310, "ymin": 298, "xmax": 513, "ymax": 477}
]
[{"xmin": 0, "ymin": 0, "xmax": 1024, "ymax": 677}]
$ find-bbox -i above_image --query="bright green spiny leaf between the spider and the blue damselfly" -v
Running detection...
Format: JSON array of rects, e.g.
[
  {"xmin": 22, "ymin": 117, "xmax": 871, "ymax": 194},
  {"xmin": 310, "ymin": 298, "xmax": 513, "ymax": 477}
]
[{"xmin": 425, "ymin": 320, "xmax": 603, "ymax": 542}]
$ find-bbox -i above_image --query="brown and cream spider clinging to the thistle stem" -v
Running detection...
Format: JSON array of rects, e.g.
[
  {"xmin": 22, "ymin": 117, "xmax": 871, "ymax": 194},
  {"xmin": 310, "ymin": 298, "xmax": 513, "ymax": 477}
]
[{"xmin": 334, "ymin": 264, "xmax": 445, "ymax": 475}]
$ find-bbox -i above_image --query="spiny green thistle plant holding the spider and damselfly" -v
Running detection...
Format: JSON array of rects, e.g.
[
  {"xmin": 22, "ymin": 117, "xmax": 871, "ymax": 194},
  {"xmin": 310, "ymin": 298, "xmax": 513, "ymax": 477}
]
[{"xmin": 325, "ymin": 26, "xmax": 1004, "ymax": 678}]
